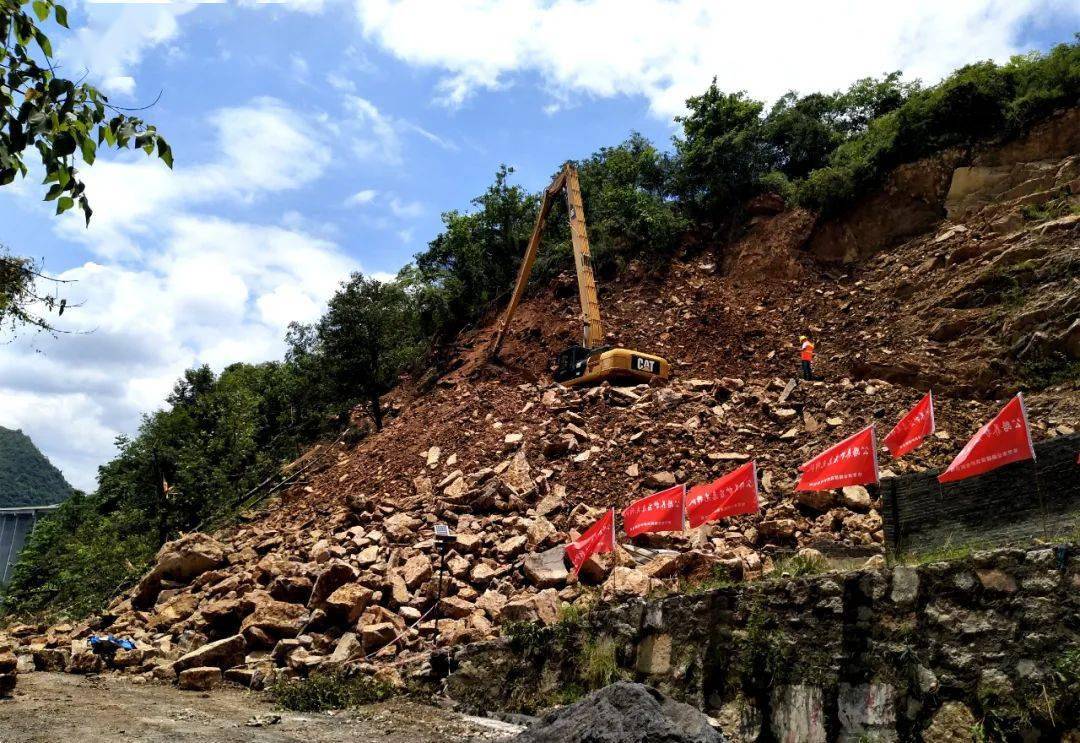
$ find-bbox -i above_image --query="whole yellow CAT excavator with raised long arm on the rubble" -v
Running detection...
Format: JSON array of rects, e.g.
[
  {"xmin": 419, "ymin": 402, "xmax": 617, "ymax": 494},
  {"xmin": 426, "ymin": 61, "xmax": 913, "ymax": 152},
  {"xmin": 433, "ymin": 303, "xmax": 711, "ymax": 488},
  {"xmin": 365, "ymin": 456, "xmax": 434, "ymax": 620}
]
[{"xmin": 488, "ymin": 163, "xmax": 671, "ymax": 386}]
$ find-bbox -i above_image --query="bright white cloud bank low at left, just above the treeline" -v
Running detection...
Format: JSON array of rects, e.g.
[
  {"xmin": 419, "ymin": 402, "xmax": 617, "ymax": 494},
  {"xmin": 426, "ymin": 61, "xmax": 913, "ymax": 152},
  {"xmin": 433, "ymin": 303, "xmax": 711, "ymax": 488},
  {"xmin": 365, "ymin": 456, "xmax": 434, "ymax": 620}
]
[{"xmin": 0, "ymin": 215, "xmax": 359, "ymax": 489}]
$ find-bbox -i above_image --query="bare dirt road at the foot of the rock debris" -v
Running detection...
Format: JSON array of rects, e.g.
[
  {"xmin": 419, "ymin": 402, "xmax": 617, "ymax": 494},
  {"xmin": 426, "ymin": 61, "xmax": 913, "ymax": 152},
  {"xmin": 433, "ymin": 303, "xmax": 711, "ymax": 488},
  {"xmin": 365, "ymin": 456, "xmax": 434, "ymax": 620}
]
[{"xmin": 0, "ymin": 673, "xmax": 515, "ymax": 743}]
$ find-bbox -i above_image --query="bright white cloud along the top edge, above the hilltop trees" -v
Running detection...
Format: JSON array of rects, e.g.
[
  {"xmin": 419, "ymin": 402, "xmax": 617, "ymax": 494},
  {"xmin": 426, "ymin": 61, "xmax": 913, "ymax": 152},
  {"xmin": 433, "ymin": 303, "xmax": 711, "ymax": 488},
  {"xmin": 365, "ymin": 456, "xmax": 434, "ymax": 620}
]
[{"xmin": 355, "ymin": 0, "xmax": 1080, "ymax": 117}]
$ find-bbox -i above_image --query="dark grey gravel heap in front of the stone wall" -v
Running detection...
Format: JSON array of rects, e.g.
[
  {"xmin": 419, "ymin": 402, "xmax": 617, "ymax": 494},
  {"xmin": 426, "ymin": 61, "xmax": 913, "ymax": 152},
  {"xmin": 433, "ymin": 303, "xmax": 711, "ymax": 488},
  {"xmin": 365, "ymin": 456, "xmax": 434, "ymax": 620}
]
[{"xmin": 514, "ymin": 681, "xmax": 725, "ymax": 743}]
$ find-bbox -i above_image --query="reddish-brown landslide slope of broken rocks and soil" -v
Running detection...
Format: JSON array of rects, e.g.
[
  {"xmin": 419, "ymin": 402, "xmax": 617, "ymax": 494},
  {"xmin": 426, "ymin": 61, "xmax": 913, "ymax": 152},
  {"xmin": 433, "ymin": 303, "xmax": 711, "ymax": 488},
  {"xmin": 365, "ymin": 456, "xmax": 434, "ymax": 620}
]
[{"xmin": 12, "ymin": 111, "xmax": 1080, "ymax": 688}]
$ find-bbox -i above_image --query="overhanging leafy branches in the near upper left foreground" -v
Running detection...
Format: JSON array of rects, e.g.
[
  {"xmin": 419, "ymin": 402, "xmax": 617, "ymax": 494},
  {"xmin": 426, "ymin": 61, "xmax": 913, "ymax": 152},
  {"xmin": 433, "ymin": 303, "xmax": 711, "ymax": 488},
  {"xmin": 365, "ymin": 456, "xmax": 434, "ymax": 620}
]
[{"xmin": 0, "ymin": 0, "xmax": 173, "ymax": 329}]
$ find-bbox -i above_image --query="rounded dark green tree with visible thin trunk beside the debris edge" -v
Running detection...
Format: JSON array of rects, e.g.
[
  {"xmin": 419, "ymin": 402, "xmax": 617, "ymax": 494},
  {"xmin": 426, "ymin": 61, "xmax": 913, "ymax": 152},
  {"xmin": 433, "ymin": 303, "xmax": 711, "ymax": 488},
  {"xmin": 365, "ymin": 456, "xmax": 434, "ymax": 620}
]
[{"xmin": 316, "ymin": 273, "xmax": 423, "ymax": 429}]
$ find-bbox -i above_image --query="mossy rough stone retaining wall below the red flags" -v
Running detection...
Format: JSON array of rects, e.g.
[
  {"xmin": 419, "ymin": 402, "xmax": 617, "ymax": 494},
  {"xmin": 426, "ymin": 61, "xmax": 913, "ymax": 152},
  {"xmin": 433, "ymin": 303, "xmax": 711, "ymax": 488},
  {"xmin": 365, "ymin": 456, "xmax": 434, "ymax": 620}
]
[{"xmin": 446, "ymin": 544, "xmax": 1080, "ymax": 742}]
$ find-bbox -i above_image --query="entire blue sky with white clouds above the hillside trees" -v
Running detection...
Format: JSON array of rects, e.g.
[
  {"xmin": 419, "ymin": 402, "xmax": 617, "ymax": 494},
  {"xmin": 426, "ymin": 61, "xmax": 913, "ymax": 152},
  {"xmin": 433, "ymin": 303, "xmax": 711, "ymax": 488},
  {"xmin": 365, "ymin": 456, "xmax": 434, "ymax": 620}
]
[{"xmin": 0, "ymin": 0, "xmax": 1080, "ymax": 488}]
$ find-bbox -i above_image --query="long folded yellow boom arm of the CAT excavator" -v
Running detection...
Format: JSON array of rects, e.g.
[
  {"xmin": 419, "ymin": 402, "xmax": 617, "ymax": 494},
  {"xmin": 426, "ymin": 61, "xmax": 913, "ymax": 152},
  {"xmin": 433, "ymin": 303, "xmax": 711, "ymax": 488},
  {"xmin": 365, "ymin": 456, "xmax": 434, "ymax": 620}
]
[{"xmin": 488, "ymin": 163, "xmax": 604, "ymax": 359}]
